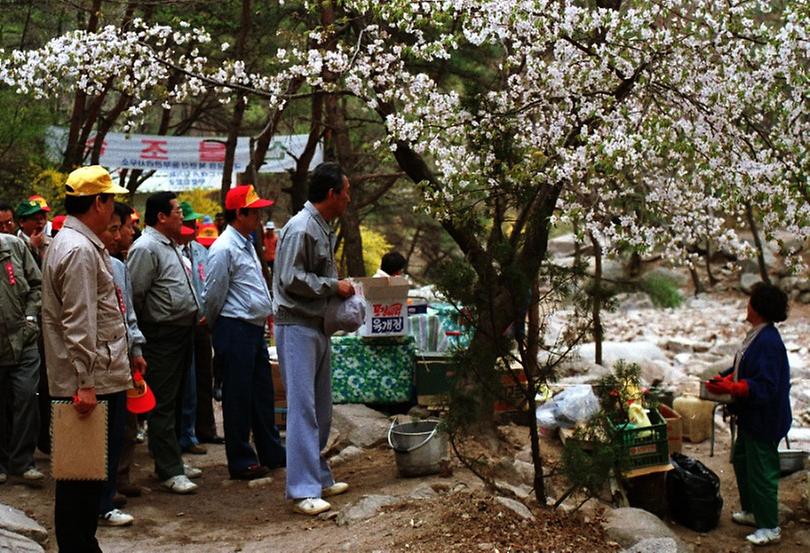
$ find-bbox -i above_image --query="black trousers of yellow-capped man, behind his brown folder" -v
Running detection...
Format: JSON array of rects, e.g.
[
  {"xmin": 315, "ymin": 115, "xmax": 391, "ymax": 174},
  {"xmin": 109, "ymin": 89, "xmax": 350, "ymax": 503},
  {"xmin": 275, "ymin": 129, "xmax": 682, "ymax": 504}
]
[{"xmin": 54, "ymin": 392, "xmax": 126, "ymax": 553}]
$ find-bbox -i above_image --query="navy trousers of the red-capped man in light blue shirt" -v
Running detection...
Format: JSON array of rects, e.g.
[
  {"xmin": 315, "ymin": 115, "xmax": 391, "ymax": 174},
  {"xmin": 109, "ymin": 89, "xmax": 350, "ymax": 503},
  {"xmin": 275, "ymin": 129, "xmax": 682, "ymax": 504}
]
[{"xmin": 214, "ymin": 317, "xmax": 286, "ymax": 474}]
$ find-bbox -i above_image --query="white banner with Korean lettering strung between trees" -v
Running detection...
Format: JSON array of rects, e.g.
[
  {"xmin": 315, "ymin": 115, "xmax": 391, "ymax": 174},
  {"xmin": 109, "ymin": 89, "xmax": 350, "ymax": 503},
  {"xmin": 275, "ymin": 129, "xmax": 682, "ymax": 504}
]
[{"xmin": 46, "ymin": 127, "xmax": 323, "ymax": 192}]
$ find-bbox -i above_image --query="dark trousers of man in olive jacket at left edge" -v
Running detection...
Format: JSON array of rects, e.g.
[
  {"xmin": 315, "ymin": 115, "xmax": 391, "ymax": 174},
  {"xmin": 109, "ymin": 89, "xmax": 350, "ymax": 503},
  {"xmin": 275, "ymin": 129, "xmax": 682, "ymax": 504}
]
[{"xmin": 0, "ymin": 345, "xmax": 40, "ymax": 474}]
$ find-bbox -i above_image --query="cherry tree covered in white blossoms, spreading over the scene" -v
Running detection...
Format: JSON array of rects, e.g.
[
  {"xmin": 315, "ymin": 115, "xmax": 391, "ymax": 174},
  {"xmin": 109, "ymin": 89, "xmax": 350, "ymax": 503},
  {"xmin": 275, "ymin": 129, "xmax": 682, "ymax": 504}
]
[{"xmin": 0, "ymin": 0, "xmax": 810, "ymax": 496}]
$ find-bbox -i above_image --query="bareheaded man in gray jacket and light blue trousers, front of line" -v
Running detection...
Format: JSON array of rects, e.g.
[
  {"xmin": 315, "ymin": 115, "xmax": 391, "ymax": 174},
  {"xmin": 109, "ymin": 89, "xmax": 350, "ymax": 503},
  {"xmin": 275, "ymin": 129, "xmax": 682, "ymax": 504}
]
[{"xmin": 273, "ymin": 163, "xmax": 354, "ymax": 515}]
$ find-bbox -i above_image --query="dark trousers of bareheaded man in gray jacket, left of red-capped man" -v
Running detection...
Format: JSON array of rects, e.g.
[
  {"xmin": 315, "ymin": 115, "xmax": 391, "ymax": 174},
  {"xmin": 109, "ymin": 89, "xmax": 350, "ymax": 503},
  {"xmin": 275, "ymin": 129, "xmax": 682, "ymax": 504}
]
[{"xmin": 139, "ymin": 323, "xmax": 193, "ymax": 480}]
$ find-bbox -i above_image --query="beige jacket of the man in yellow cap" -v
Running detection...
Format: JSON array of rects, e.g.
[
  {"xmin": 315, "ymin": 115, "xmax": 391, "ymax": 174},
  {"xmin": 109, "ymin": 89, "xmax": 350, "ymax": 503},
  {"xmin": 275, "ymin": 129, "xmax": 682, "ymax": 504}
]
[{"xmin": 42, "ymin": 216, "xmax": 131, "ymax": 397}]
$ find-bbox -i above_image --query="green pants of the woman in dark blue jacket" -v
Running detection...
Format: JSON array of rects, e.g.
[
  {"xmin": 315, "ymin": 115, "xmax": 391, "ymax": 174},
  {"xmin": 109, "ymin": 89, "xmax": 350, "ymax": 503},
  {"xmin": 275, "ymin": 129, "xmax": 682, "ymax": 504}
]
[{"xmin": 732, "ymin": 430, "xmax": 779, "ymax": 528}]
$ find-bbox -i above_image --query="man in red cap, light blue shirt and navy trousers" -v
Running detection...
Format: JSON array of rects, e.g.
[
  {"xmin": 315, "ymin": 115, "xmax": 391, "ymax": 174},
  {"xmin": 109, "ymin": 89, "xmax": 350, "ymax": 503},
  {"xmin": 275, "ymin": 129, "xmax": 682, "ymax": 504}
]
[{"xmin": 205, "ymin": 184, "xmax": 286, "ymax": 480}]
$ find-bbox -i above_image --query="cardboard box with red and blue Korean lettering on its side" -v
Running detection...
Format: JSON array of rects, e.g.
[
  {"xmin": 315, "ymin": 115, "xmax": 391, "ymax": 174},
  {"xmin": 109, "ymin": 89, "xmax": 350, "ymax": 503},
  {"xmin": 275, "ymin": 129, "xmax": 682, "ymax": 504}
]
[{"xmin": 355, "ymin": 276, "xmax": 410, "ymax": 338}]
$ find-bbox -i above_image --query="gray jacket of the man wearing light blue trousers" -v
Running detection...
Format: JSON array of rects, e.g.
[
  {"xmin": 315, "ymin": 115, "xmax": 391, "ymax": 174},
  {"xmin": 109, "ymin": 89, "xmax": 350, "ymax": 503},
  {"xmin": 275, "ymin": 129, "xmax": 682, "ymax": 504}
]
[{"xmin": 273, "ymin": 202, "xmax": 338, "ymax": 329}]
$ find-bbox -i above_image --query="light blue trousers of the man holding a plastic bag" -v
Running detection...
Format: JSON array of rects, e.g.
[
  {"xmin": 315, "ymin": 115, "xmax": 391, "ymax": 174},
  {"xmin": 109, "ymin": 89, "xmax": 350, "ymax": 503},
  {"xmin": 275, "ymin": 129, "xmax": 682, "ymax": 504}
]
[{"xmin": 275, "ymin": 324, "xmax": 335, "ymax": 499}]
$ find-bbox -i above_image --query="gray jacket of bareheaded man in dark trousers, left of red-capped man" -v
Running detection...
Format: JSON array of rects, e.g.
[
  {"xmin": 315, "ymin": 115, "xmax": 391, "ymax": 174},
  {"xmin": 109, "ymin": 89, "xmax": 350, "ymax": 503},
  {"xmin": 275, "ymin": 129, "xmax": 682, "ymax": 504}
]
[{"xmin": 129, "ymin": 227, "xmax": 200, "ymax": 326}]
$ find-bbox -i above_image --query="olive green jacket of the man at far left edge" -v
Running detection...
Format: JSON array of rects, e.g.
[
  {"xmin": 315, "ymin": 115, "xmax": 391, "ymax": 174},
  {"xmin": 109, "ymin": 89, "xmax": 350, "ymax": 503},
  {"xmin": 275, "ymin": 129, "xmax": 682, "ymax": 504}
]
[{"xmin": 0, "ymin": 234, "xmax": 42, "ymax": 365}]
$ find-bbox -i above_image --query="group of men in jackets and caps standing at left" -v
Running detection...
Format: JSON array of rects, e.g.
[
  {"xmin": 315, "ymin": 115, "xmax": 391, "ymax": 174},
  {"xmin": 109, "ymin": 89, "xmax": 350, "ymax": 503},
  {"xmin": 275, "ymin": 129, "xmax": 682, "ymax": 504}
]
[{"xmin": 0, "ymin": 163, "xmax": 354, "ymax": 551}]
